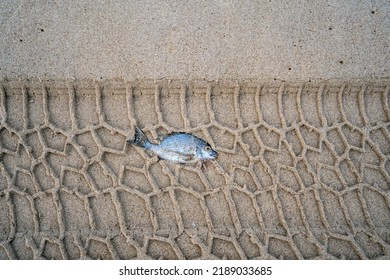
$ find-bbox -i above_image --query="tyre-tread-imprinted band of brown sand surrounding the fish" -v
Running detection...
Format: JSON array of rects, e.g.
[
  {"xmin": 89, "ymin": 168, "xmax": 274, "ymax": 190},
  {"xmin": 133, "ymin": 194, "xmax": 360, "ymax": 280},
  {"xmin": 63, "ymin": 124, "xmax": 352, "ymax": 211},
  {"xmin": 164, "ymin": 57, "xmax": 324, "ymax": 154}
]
[{"xmin": 0, "ymin": 80, "xmax": 390, "ymax": 259}]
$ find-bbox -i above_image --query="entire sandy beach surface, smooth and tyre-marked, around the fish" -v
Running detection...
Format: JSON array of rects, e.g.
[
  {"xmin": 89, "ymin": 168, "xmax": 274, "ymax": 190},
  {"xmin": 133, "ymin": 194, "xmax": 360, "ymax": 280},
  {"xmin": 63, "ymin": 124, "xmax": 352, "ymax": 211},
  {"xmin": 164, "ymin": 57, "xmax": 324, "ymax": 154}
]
[{"xmin": 0, "ymin": 1, "xmax": 390, "ymax": 259}]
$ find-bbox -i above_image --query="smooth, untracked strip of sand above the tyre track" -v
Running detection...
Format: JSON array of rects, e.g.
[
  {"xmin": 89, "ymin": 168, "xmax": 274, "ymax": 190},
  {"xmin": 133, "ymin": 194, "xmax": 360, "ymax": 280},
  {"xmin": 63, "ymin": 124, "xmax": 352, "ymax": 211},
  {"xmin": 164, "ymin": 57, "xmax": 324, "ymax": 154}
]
[{"xmin": 0, "ymin": 0, "xmax": 390, "ymax": 81}]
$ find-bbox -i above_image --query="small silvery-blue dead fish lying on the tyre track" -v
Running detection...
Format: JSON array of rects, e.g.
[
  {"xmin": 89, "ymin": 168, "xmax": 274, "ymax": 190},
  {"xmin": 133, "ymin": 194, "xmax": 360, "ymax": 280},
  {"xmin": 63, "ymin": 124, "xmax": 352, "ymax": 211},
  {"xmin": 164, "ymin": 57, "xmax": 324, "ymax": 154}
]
[{"xmin": 127, "ymin": 127, "xmax": 218, "ymax": 164}]
